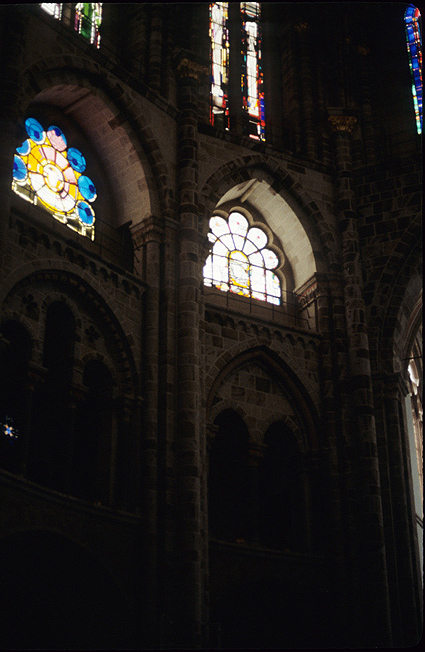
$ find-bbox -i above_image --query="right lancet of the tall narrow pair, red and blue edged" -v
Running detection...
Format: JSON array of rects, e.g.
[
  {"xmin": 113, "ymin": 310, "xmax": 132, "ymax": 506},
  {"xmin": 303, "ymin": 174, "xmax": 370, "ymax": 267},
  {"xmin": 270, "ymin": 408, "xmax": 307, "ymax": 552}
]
[{"xmin": 241, "ymin": 2, "xmax": 265, "ymax": 140}]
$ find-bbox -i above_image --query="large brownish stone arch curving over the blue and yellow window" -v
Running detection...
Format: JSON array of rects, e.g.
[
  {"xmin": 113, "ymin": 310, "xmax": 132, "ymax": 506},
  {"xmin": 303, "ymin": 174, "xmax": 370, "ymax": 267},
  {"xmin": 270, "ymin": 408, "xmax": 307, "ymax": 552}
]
[{"xmin": 13, "ymin": 54, "xmax": 173, "ymax": 232}]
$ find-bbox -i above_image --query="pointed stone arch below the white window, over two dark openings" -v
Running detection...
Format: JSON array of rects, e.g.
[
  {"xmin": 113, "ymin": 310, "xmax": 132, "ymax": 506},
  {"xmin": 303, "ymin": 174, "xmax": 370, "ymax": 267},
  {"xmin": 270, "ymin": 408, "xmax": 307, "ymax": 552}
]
[{"xmin": 206, "ymin": 345, "xmax": 319, "ymax": 452}]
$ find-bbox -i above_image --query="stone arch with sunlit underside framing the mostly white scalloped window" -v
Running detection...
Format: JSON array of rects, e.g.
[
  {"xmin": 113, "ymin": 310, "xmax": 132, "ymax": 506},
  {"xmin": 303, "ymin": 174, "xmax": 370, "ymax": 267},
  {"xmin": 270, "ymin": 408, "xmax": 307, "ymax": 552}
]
[{"xmin": 200, "ymin": 154, "xmax": 339, "ymax": 287}]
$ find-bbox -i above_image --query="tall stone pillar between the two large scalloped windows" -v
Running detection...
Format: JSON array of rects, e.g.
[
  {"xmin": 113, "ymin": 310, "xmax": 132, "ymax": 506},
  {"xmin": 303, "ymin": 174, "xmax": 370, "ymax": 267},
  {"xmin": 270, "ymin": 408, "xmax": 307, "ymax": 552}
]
[{"xmin": 175, "ymin": 58, "xmax": 208, "ymax": 647}]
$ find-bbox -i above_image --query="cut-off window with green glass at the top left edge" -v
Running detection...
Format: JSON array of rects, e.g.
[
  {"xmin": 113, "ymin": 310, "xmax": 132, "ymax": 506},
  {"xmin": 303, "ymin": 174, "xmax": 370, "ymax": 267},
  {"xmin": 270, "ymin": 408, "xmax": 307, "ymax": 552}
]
[{"xmin": 40, "ymin": 2, "xmax": 103, "ymax": 48}]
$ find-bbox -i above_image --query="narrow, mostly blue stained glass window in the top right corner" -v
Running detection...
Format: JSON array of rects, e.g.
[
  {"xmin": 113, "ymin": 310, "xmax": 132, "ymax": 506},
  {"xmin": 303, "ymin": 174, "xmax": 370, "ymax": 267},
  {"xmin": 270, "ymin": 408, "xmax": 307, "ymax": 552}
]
[{"xmin": 404, "ymin": 5, "xmax": 422, "ymax": 134}]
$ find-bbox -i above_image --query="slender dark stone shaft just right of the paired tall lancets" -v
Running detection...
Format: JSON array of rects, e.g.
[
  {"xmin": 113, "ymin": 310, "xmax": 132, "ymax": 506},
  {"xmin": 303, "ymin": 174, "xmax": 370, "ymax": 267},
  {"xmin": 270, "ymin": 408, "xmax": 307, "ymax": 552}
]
[{"xmin": 295, "ymin": 22, "xmax": 317, "ymax": 159}]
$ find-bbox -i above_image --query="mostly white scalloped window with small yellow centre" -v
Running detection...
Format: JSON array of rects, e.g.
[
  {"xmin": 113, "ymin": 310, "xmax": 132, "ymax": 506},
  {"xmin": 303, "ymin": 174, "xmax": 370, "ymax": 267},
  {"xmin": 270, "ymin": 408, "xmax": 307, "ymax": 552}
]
[{"xmin": 204, "ymin": 211, "xmax": 281, "ymax": 305}]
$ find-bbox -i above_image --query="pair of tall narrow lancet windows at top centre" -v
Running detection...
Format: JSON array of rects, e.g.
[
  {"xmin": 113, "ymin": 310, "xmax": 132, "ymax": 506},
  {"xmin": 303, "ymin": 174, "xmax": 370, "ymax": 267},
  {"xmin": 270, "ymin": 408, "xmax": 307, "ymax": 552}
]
[{"xmin": 209, "ymin": 2, "xmax": 265, "ymax": 140}]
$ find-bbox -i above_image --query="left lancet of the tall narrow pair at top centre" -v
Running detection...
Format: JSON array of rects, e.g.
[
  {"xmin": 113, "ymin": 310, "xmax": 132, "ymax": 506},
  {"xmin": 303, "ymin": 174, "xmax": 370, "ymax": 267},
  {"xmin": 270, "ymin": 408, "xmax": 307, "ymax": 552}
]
[{"xmin": 210, "ymin": 2, "xmax": 229, "ymax": 129}]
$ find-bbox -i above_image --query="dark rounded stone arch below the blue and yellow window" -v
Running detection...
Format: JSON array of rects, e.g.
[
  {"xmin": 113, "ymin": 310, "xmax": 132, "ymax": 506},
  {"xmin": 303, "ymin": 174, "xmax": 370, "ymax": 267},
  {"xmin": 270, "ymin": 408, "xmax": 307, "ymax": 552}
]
[{"xmin": 0, "ymin": 261, "xmax": 139, "ymax": 398}]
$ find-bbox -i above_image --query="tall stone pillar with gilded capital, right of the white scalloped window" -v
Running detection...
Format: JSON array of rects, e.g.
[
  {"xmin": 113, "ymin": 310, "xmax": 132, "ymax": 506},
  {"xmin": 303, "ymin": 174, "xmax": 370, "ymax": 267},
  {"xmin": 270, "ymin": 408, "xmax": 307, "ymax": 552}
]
[{"xmin": 329, "ymin": 114, "xmax": 392, "ymax": 647}]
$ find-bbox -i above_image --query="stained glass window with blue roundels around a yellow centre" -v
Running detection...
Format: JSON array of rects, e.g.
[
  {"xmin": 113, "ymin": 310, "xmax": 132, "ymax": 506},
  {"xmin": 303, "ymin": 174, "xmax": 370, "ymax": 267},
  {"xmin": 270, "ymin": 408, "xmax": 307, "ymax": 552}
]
[{"xmin": 12, "ymin": 118, "xmax": 97, "ymax": 240}]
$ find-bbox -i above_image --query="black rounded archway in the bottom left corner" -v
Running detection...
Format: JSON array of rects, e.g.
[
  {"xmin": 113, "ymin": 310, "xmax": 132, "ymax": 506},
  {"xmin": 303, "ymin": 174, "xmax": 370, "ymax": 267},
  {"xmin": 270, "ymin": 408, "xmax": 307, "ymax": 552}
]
[{"xmin": 0, "ymin": 531, "xmax": 136, "ymax": 650}]
